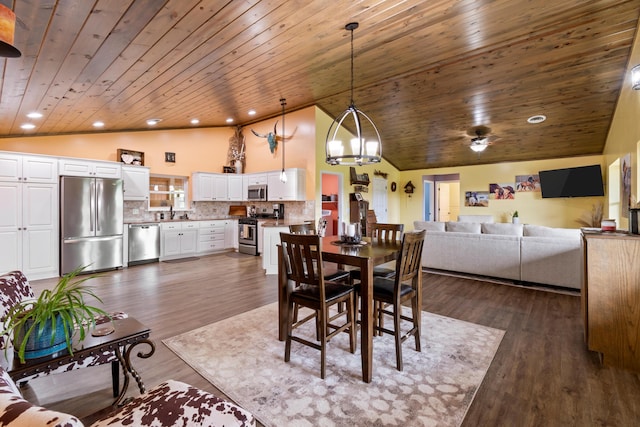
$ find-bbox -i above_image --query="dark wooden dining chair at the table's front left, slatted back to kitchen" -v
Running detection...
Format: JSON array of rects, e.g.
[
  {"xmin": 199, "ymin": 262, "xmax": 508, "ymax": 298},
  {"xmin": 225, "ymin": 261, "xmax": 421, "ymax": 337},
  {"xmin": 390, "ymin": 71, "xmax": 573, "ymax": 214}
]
[{"xmin": 280, "ymin": 233, "xmax": 356, "ymax": 379}]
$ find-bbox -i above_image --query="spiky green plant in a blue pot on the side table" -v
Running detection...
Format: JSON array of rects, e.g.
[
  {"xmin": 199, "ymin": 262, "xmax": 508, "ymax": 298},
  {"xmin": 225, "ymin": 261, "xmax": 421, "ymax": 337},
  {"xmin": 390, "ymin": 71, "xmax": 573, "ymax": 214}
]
[{"xmin": 2, "ymin": 267, "xmax": 108, "ymax": 363}]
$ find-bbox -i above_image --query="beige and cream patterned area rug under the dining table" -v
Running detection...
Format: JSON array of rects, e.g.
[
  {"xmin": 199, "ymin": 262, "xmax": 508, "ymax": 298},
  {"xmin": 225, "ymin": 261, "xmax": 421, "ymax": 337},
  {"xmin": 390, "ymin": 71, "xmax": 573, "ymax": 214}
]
[{"xmin": 163, "ymin": 303, "xmax": 504, "ymax": 427}]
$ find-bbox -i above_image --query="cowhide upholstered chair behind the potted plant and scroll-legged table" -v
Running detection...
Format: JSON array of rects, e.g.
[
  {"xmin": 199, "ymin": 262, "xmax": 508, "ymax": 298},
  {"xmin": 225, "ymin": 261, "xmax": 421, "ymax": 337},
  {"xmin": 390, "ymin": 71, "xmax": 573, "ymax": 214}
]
[{"xmin": 0, "ymin": 271, "xmax": 127, "ymax": 397}]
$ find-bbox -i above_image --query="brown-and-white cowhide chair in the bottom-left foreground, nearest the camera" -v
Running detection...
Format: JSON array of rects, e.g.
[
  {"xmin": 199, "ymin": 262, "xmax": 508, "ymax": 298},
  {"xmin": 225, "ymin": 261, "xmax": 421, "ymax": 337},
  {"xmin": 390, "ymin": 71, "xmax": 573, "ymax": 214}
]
[{"xmin": 0, "ymin": 368, "xmax": 256, "ymax": 427}]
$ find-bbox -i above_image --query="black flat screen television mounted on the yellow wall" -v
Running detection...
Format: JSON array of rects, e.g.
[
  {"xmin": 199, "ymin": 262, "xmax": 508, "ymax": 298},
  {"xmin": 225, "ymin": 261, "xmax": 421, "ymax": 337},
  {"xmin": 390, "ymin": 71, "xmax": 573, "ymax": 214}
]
[{"xmin": 538, "ymin": 165, "xmax": 604, "ymax": 198}]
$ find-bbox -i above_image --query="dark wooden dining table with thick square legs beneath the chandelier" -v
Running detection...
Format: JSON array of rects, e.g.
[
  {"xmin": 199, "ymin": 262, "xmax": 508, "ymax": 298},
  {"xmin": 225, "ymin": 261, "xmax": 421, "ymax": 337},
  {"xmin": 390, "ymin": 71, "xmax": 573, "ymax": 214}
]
[{"xmin": 278, "ymin": 236, "xmax": 422, "ymax": 383}]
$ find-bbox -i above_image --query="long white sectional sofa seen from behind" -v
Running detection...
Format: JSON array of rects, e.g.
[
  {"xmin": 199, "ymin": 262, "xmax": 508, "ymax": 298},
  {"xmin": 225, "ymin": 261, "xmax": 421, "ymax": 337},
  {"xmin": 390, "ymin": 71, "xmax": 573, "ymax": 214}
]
[{"xmin": 414, "ymin": 218, "xmax": 583, "ymax": 289}]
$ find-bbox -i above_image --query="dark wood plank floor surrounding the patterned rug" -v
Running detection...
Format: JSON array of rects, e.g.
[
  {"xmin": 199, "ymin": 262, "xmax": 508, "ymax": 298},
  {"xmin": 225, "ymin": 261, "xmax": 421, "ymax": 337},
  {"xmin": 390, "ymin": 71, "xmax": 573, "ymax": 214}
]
[{"xmin": 25, "ymin": 253, "xmax": 640, "ymax": 427}]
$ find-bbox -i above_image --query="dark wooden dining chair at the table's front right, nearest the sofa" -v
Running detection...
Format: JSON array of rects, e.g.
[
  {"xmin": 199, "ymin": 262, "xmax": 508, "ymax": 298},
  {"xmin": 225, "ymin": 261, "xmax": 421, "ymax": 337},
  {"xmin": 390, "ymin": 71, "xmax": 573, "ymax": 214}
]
[{"xmin": 373, "ymin": 230, "xmax": 426, "ymax": 371}]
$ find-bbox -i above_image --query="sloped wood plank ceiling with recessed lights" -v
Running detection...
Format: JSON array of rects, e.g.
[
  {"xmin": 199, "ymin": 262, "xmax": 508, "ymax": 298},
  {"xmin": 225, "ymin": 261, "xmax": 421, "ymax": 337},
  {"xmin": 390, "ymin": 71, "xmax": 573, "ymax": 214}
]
[{"xmin": 0, "ymin": 0, "xmax": 640, "ymax": 170}]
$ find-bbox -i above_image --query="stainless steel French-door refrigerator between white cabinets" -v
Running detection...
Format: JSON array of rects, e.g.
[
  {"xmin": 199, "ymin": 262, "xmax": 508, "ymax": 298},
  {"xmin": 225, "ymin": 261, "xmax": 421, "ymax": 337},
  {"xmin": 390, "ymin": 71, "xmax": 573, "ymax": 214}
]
[{"xmin": 60, "ymin": 176, "xmax": 124, "ymax": 275}]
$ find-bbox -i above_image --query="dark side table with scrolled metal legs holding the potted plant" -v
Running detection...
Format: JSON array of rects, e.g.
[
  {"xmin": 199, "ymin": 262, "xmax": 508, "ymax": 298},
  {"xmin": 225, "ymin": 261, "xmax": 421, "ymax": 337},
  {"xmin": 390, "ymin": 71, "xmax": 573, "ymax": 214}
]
[{"xmin": 9, "ymin": 317, "xmax": 156, "ymax": 406}]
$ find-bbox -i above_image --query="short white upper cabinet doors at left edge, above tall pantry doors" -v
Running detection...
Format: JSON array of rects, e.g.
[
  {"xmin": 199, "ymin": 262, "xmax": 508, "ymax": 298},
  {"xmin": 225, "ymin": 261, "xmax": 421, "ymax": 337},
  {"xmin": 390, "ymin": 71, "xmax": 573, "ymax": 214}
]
[{"xmin": 0, "ymin": 152, "xmax": 58, "ymax": 184}]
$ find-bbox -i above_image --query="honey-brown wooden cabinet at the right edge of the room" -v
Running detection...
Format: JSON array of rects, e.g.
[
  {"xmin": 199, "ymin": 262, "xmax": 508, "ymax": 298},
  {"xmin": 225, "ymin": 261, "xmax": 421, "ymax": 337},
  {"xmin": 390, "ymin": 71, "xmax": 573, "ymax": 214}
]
[{"xmin": 582, "ymin": 232, "xmax": 640, "ymax": 372}]
